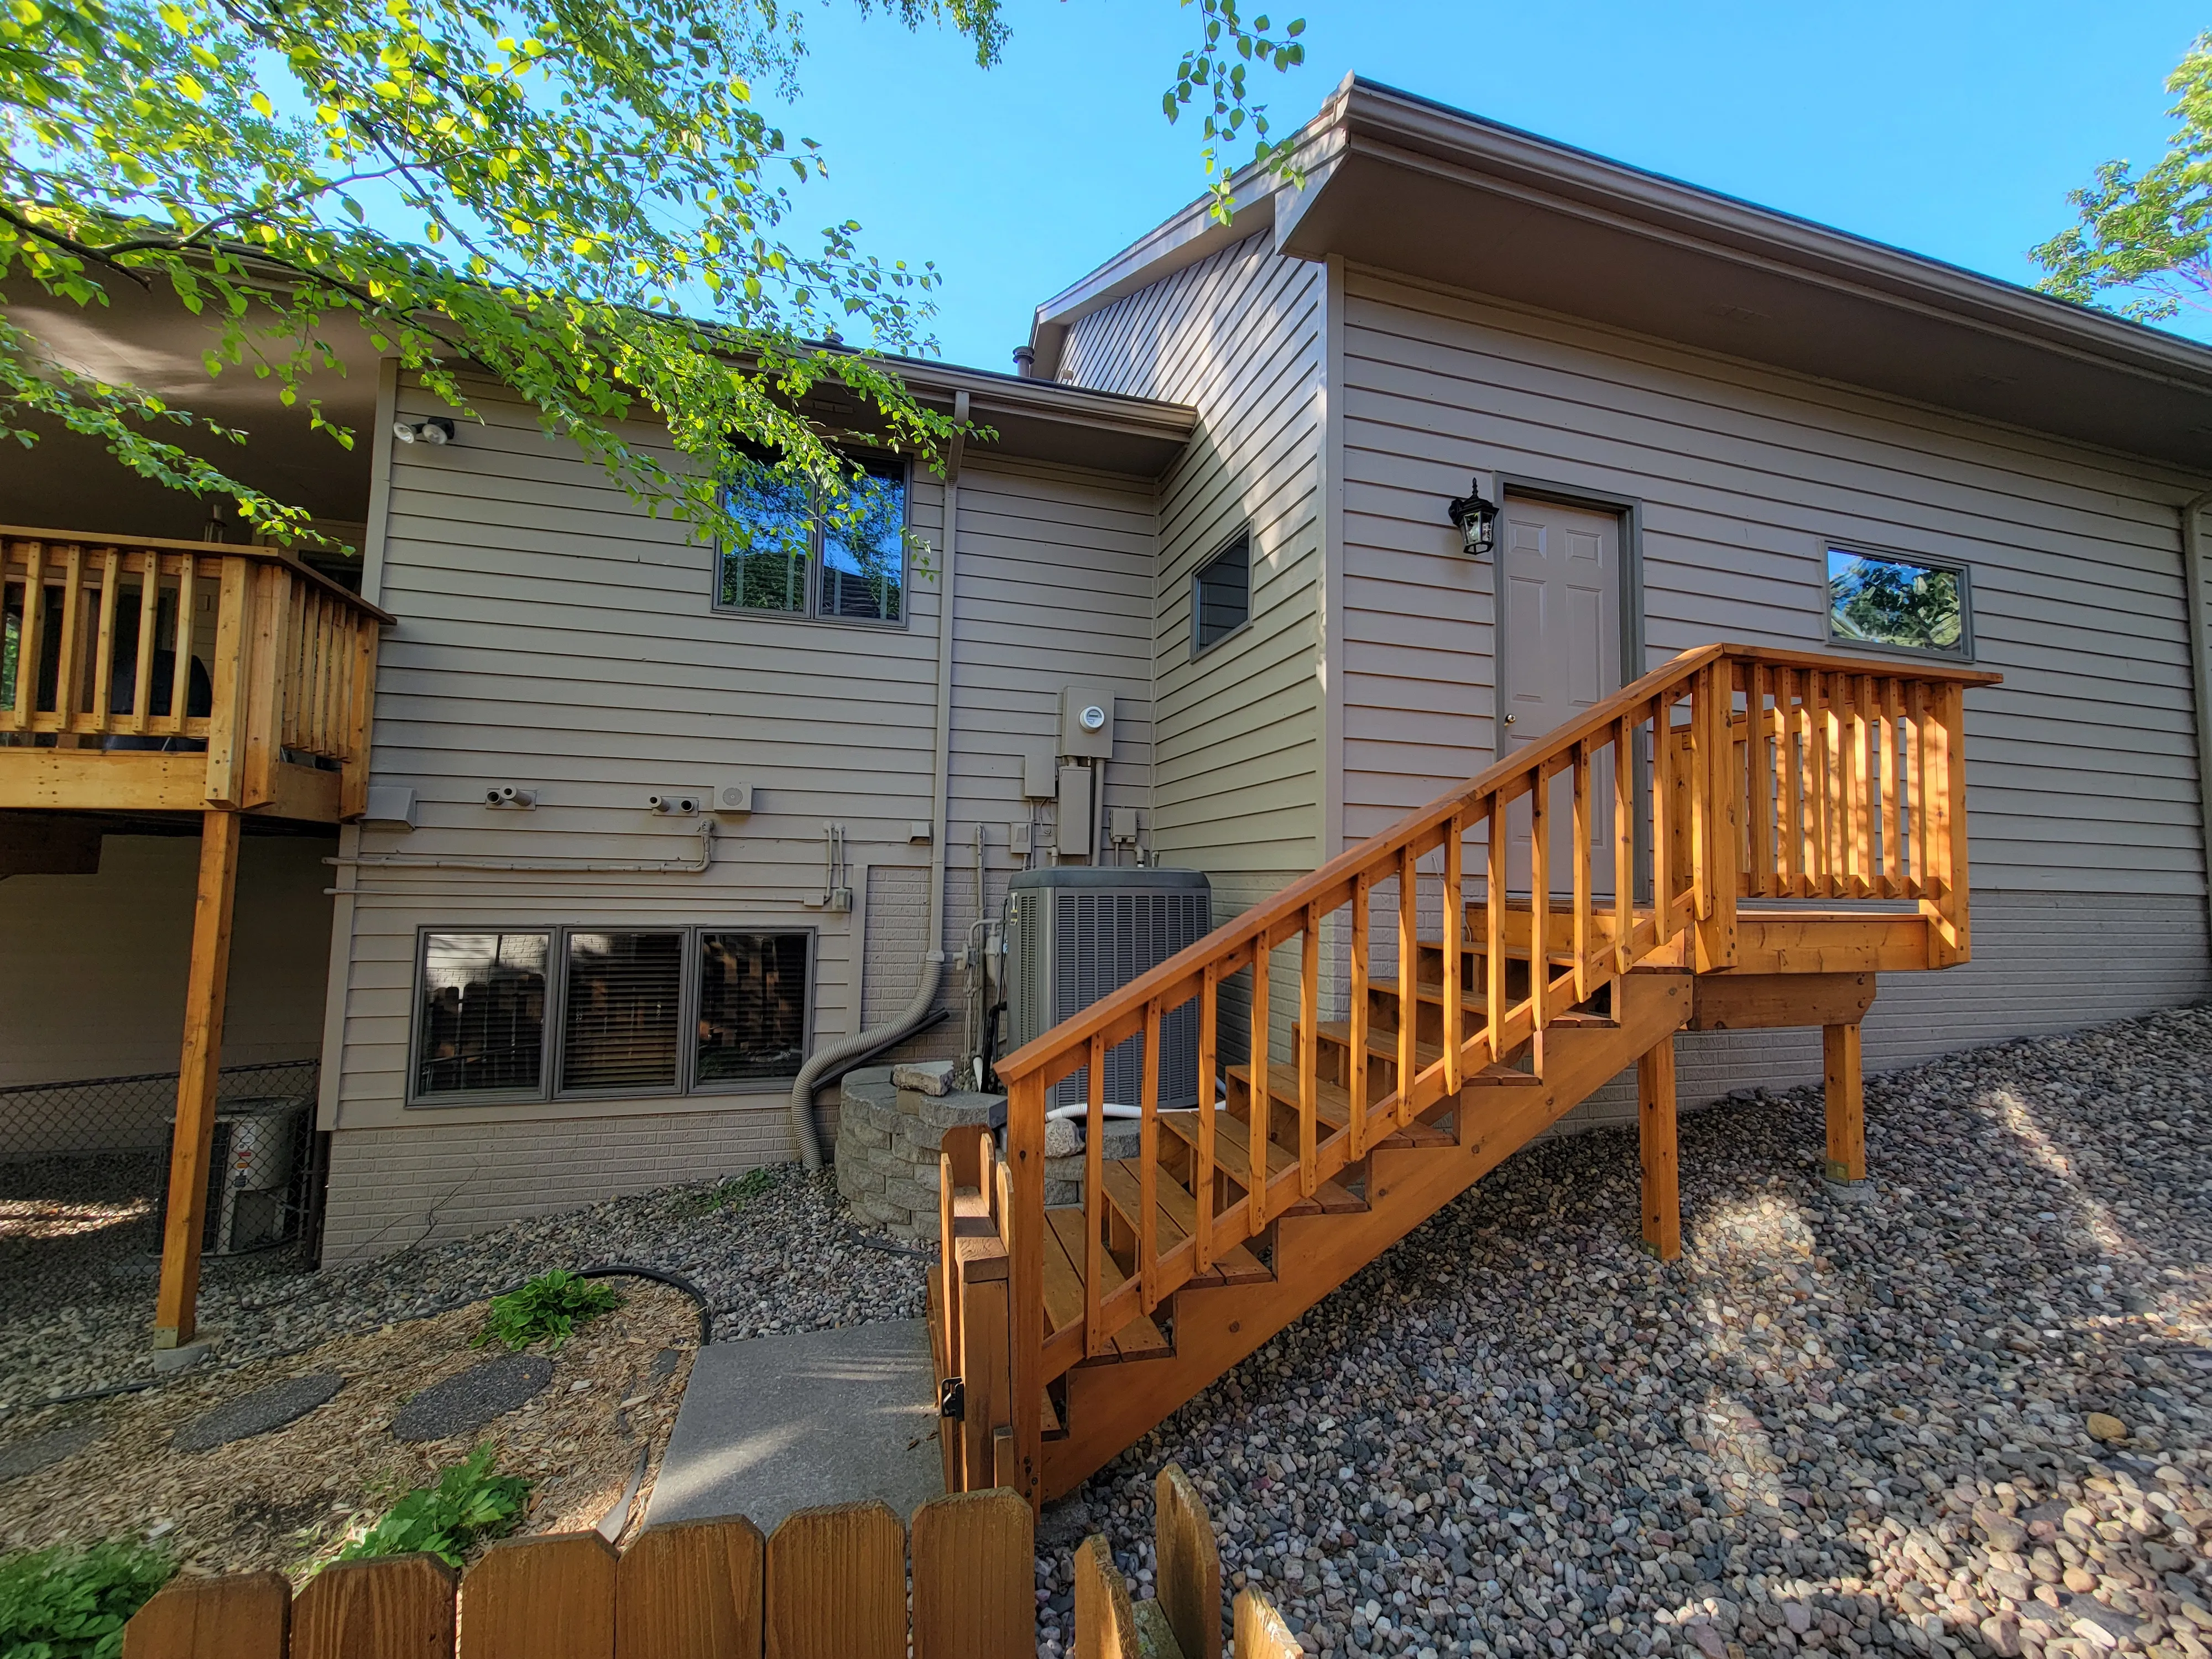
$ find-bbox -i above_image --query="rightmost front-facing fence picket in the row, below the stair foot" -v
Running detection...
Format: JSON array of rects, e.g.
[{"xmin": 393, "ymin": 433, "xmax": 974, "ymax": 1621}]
[{"xmin": 914, "ymin": 1486, "xmax": 1037, "ymax": 1659}]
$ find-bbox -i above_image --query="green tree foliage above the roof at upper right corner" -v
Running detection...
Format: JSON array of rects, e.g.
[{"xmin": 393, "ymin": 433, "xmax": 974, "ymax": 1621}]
[{"xmin": 2031, "ymin": 35, "xmax": 2212, "ymax": 323}]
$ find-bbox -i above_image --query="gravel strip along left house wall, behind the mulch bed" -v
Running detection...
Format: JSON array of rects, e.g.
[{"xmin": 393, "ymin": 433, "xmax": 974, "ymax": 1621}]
[{"xmin": 0, "ymin": 1164, "xmax": 925, "ymax": 1429}]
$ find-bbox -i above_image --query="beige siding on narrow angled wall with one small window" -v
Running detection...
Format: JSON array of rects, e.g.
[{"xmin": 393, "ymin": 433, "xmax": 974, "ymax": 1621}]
[{"xmin": 1062, "ymin": 234, "xmax": 1325, "ymax": 898}]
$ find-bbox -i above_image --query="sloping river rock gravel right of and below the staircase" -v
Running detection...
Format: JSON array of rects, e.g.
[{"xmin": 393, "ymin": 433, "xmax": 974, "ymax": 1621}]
[{"xmin": 1037, "ymin": 1009, "xmax": 2212, "ymax": 1659}]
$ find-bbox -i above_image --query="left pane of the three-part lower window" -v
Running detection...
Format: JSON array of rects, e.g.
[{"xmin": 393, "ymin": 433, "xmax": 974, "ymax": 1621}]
[{"xmin": 414, "ymin": 933, "xmax": 551, "ymax": 1097}]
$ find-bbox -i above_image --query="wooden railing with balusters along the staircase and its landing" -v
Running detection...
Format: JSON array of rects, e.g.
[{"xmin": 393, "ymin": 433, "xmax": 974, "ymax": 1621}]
[{"xmin": 969, "ymin": 644, "xmax": 2000, "ymax": 1495}]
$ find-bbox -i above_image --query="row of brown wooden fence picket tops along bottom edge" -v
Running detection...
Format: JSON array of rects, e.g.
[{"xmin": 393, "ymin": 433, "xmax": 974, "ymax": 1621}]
[{"xmin": 124, "ymin": 1464, "xmax": 1298, "ymax": 1659}]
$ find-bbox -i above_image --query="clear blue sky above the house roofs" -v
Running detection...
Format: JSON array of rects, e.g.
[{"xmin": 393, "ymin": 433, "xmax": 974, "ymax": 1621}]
[{"xmin": 752, "ymin": 0, "xmax": 2212, "ymax": 369}]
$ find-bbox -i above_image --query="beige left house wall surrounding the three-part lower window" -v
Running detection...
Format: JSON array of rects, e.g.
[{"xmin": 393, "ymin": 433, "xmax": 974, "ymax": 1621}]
[{"xmin": 325, "ymin": 387, "xmax": 1155, "ymax": 1261}]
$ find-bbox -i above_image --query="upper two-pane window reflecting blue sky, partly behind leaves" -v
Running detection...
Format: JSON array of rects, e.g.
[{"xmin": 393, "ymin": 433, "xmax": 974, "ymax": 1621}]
[{"xmin": 714, "ymin": 449, "xmax": 907, "ymax": 622}]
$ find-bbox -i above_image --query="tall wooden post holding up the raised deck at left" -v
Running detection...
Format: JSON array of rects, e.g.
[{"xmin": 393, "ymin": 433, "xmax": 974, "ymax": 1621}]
[{"xmin": 153, "ymin": 812, "xmax": 239, "ymax": 1347}]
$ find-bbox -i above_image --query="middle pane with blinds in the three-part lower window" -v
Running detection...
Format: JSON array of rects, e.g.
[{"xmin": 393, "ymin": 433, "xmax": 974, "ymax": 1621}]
[{"xmin": 560, "ymin": 931, "xmax": 684, "ymax": 1093}]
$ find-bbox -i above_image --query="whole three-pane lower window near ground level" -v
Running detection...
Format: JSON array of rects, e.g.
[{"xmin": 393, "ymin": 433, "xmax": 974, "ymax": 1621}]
[{"xmin": 409, "ymin": 927, "xmax": 814, "ymax": 1104}]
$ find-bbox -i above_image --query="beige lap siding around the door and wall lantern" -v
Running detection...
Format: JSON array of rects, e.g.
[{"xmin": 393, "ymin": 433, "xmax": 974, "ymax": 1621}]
[{"xmin": 1343, "ymin": 272, "xmax": 2203, "ymax": 896}]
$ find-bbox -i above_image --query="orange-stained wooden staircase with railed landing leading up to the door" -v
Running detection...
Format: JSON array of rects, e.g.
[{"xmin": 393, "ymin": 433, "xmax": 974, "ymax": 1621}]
[{"xmin": 931, "ymin": 646, "xmax": 1997, "ymax": 1502}]
